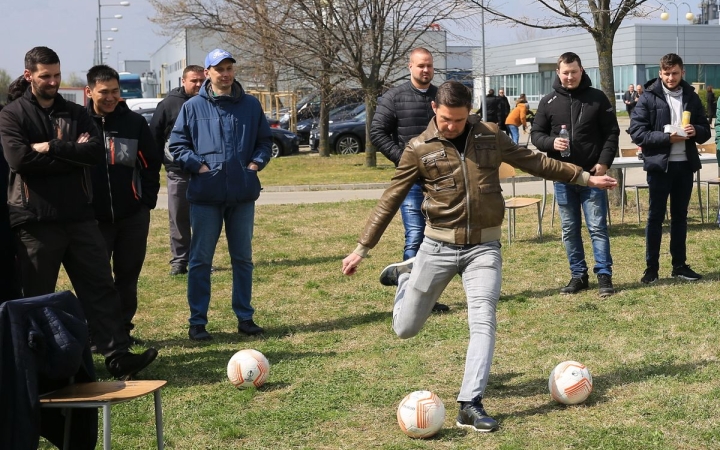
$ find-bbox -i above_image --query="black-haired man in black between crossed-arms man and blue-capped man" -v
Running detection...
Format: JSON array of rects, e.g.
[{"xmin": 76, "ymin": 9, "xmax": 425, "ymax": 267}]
[{"xmin": 85, "ymin": 65, "xmax": 162, "ymax": 344}]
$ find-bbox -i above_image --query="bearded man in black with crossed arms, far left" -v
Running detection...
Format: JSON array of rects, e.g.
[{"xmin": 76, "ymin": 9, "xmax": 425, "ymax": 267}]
[{"xmin": 0, "ymin": 47, "xmax": 157, "ymax": 378}]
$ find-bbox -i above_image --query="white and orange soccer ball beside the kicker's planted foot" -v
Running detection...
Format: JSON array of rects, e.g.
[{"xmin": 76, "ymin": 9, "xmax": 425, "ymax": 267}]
[{"xmin": 397, "ymin": 391, "xmax": 445, "ymax": 438}]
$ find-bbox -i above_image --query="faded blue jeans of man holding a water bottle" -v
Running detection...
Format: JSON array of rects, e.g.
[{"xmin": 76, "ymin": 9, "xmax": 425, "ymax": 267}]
[{"xmin": 555, "ymin": 182, "xmax": 612, "ymax": 278}]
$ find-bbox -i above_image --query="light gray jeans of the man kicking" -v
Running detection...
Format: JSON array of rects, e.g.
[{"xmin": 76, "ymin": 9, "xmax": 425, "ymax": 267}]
[{"xmin": 393, "ymin": 237, "xmax": 502, "ymax": 402}]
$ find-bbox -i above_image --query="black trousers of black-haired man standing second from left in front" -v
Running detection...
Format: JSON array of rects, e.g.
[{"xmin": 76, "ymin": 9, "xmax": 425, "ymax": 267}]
[{"xmin": 98, "ymin": 206, "xmax": 150, "ymax": 332}]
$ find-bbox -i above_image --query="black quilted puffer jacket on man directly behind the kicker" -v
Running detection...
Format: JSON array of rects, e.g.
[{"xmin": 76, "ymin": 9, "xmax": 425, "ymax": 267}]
[{"xmin": 370, "ymin": 81, "xmax": 437, "ymax": 166}]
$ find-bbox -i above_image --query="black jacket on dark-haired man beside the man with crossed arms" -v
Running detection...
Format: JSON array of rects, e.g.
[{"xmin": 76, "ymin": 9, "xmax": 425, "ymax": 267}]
[{"xmin": 88, "ymin": 100, "xmax": 162, "ymax": 222}]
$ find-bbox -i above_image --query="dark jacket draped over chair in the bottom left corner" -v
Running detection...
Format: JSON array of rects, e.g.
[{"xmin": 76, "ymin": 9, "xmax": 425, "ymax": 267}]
[{"xmin": 0, "ymin": 291, "xmax": 98, "ymax": 450}]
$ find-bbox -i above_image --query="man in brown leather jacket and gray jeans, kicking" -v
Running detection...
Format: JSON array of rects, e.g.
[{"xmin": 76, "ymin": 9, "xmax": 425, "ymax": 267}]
[{"xmin": 342, "ymin": 81, "xmax": 617, "ymax": 432}]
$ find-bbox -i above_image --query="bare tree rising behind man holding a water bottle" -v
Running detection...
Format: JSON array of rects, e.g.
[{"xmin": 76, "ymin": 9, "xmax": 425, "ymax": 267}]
[{"xmin": 468, "ymin": 0, "xmax": 658, "ymax": 107}]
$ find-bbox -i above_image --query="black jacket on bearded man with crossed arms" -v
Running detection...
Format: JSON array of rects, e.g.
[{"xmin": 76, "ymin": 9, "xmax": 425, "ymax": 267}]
[{"xmin": 0, "ymin": 88, "xmax": 105, "ymax": 226}]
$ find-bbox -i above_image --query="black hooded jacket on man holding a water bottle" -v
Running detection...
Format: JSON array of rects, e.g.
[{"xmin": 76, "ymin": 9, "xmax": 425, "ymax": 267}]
[{"xmin": 530, "ymin": 72, "xmax": 620, "ymax": 171}]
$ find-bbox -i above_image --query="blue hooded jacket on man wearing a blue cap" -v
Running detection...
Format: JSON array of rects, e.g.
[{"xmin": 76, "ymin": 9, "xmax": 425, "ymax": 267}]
[{"xmin": 169, "ymin": 79, "xmax": 272, "ymax": 205}]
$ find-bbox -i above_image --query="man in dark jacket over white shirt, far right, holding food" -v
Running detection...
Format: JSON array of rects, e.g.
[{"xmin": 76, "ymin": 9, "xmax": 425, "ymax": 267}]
[{"xmin": 628, "ymin": 53, "xmax": 710, "ymax": 284}]
